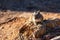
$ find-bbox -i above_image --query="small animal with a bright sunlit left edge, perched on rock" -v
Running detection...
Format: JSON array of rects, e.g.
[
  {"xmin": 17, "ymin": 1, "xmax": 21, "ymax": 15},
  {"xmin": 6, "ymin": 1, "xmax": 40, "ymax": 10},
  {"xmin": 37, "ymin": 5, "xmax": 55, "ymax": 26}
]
[{"xmin": 32, "ymin": 11, "xmax": 43, "ymax": 25}]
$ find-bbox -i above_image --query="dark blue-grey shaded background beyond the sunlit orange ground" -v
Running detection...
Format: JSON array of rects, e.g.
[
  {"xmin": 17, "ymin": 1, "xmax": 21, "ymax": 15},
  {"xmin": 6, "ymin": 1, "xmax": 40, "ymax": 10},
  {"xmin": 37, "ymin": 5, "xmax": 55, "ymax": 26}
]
[{"xmin": 0, "ymin": 0, "xmax": 60, "ymax": 12}]
